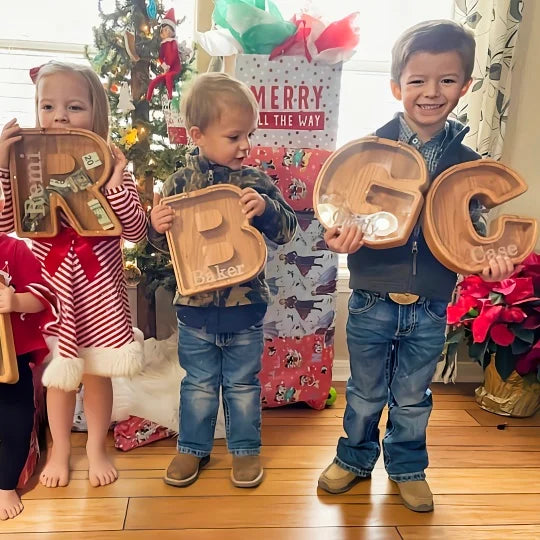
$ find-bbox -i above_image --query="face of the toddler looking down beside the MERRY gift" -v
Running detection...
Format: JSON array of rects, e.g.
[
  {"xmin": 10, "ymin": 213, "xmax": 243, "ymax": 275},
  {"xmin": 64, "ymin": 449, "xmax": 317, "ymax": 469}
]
[{"xmin": 189, "ymin": 105, "xmax": 257, "ymax": 171}]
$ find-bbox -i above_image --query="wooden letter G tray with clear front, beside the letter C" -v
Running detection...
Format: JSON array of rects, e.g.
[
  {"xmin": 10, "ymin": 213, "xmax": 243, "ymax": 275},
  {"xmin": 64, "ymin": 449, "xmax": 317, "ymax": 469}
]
[{"xmin": 313, "ymin": 137, "xmax": 429, "ymax": 249}]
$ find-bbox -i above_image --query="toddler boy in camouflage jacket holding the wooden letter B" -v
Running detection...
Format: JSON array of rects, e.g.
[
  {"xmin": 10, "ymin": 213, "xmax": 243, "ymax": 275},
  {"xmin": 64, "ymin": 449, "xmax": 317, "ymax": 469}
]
[{"xmin": 148, "ymin": 73, "xmax": 297, "ymax": 487}]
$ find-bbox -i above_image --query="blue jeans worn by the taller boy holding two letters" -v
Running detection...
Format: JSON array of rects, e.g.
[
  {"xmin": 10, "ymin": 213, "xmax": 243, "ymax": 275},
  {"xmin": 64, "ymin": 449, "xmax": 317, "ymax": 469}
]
[{"xmin": 335, "ymin": 290, "xmax": 448, "ymax": 482}]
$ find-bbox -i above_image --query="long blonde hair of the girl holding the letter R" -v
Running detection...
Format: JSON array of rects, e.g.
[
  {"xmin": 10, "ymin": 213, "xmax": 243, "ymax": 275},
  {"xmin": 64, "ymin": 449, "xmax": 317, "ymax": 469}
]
[{"xmin": 35, "ymin": 61, "xmax": 109, "ymax": 140}]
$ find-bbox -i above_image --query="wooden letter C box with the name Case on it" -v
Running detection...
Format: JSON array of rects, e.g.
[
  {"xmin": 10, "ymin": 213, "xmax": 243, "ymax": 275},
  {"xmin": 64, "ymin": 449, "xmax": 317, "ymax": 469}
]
[{"xmin": 423, "ymin": 159, "xmax": 537, "ymax": 274}]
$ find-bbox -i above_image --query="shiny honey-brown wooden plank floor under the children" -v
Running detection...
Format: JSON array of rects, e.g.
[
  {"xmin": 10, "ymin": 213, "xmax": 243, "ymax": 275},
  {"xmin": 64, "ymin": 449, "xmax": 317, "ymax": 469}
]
[{"xmin": 0, "ymin": 384, "xmax": 540, "ymax": 540}]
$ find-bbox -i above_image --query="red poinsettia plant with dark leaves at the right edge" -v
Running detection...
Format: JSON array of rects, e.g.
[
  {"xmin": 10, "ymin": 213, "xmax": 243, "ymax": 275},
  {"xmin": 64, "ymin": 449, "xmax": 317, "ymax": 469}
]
[{"xmin": 447, "ymin": 253, "xmax": 540, "ymax": 381}]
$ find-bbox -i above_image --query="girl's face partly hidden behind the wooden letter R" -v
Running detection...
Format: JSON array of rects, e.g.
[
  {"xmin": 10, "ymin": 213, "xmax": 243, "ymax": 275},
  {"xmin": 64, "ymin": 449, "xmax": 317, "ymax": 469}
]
[{"xmin": 37, "ymin": 71, "xmax": 94, "ymax": 130}]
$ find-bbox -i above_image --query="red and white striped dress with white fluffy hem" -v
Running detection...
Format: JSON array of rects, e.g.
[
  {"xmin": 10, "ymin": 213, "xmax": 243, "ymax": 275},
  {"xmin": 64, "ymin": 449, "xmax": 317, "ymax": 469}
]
[{"xmin": 0, "ymin": 169, "xmax": 147, "ymax": 390}]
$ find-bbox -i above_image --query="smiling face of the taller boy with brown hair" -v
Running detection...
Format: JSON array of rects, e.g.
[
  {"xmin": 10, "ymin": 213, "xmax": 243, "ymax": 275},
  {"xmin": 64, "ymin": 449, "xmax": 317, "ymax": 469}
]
[{"xmin": 391, "ymin": 51, "xmax": 471, "ymax": 142}]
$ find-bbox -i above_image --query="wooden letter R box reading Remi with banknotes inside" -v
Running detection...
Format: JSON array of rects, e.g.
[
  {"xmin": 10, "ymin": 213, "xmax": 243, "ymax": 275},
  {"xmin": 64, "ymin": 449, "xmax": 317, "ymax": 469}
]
[{"xmin": 10, "ymin": 129, "xmax": 122, "ymax": 238}]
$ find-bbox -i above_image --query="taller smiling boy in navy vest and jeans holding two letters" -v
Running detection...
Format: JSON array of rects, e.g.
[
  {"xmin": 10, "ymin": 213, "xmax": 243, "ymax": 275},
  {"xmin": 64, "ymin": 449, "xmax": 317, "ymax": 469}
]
[{"xmin": 319, "ymin": 20, "xmax": 513, "ymax": 512}]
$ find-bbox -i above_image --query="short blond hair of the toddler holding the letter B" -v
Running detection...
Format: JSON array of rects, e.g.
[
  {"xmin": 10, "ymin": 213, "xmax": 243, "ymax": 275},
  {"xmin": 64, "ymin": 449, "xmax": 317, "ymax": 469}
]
[{"xmin": 180, "ymin": 72, "xmax": 259, "ymax": 131}]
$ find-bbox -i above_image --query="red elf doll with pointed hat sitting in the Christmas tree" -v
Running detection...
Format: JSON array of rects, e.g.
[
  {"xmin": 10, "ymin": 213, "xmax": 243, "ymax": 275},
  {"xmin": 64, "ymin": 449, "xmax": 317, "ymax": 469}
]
[{"xmin": 146, "ymin": 8, "xmax": 182, "ymax": 101}]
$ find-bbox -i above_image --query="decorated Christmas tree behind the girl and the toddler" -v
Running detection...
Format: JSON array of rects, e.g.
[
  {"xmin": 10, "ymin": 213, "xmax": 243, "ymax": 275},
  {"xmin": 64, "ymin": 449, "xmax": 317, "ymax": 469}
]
[{"xmin": 89, "ymin": 0, "xmax": 193, "ymax": 334}]
